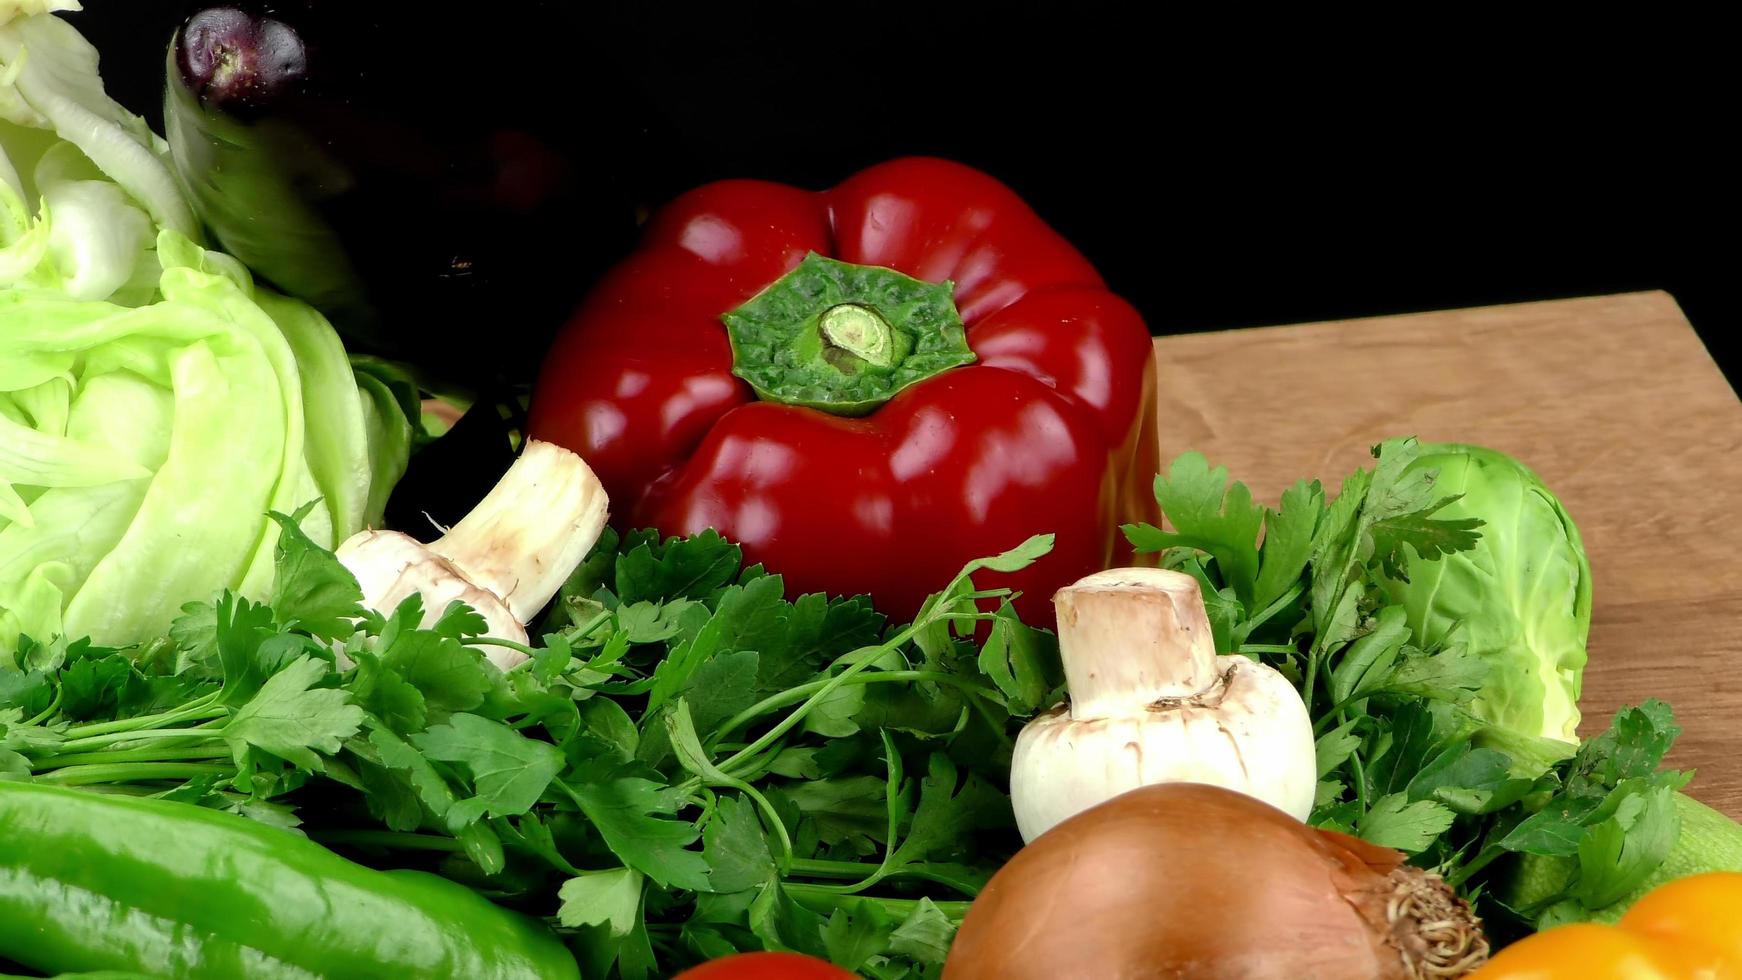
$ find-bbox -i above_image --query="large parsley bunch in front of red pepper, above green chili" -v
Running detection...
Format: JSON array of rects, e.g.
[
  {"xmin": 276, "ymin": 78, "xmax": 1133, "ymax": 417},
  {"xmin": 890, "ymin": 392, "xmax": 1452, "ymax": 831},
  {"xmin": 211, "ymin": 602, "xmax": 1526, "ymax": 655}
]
[{"xmin": 0, "ymin": 515, "xmax": 1061, "ymax": 978}]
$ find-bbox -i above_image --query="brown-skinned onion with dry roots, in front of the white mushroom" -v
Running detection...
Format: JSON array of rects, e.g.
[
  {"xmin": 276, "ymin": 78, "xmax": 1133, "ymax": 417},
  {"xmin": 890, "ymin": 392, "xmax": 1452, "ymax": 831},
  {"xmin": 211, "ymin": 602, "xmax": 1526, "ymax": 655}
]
[{"xmin": 944, "ymin": 783, "xmax": 1488, "ymax": 980}]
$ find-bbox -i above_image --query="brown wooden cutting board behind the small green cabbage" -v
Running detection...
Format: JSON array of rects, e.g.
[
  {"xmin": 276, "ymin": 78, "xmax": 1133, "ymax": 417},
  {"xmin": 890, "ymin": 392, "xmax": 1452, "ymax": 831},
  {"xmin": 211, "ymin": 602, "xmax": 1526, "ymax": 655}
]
[{"xmin": 1155, "ymin": 292, "xmax": 1742, "ymax": 818}]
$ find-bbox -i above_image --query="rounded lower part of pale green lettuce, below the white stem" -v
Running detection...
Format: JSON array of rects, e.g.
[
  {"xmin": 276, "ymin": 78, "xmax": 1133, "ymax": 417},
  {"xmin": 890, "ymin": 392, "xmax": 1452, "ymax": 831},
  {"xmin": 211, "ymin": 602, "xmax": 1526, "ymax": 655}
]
[{"xmin": 0, "ymin": 230, "xmax": 409, "ymax": 651}]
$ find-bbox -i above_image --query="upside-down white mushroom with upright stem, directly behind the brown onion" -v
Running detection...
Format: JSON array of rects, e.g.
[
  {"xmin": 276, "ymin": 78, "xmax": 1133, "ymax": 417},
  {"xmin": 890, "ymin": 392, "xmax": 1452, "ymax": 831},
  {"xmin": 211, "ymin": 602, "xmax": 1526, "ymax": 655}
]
[{"xmin": 1010, "ymin": 567, "xmax": 1319, "ymax": 841}]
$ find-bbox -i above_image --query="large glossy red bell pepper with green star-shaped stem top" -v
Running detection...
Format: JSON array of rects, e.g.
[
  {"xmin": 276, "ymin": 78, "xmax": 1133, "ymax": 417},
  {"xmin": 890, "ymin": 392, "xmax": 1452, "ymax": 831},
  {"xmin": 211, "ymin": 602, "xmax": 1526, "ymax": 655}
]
[{"xmin": 530, "ymin": 158, "xmax": 1158, "ymax": 621}]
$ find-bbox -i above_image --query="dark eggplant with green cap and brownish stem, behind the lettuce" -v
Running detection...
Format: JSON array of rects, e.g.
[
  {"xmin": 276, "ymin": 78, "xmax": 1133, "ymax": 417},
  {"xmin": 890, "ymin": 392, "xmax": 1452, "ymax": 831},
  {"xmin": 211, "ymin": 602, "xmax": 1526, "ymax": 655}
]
[{"xmin": 164, "ymin": 0, "xmax": 645, "ymax": 392}]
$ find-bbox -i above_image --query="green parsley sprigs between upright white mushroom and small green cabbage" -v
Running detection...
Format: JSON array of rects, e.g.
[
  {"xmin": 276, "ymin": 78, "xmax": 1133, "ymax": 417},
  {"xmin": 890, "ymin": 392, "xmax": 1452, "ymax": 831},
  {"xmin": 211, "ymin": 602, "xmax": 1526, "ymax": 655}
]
[{"xmin": 1125, "ymin": 439, "xmax": 1691, "ymax": 924}]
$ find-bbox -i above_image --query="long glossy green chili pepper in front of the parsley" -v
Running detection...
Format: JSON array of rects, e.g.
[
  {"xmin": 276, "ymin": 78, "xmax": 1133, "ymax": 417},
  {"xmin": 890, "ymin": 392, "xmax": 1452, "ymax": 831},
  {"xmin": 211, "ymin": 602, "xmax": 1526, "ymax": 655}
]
[{"xmin": 0, "ymin": 782, "xmax": 580, "ymax": 980}]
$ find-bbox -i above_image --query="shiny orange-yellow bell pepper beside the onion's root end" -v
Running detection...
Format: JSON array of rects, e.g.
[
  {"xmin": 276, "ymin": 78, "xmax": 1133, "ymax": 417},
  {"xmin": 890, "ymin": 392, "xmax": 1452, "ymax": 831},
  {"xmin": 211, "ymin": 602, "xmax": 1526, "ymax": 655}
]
[{"xmin": 1470, "ymin": 872, "xmax": 1742, "ymax": 980}]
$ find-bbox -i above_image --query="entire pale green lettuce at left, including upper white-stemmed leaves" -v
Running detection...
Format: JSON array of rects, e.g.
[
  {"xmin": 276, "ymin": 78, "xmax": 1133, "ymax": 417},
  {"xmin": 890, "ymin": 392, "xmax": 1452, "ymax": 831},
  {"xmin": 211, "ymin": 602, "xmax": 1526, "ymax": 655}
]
[{"xmin": 0, "ymin": 7, "xmax": 411, "ymax": 654}]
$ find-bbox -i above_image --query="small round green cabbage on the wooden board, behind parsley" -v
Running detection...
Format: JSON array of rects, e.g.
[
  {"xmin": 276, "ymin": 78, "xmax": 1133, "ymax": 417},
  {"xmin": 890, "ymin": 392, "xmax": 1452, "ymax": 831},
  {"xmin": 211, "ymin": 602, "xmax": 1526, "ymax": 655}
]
[{"xmin": 1387, "ymin": 444, "xmax": 1590, "ymax": 759}]
